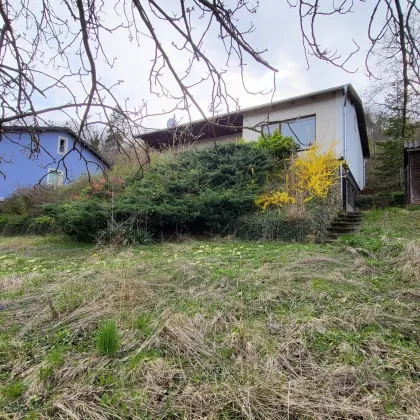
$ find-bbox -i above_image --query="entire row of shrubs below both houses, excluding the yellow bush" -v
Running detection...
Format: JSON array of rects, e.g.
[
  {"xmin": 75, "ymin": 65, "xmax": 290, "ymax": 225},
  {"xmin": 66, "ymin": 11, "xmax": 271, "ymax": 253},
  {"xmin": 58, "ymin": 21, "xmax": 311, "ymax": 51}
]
[{"xmin": 0, "ymin": 141, "xmax": 342, "ymax": 245}]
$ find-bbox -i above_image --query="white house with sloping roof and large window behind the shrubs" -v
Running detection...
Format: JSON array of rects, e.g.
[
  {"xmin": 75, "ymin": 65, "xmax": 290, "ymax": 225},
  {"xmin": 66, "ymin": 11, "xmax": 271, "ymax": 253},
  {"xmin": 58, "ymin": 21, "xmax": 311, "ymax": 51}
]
[{"xmin": 140, "ymin": 84, "xmax": 369, "ymax": 211}]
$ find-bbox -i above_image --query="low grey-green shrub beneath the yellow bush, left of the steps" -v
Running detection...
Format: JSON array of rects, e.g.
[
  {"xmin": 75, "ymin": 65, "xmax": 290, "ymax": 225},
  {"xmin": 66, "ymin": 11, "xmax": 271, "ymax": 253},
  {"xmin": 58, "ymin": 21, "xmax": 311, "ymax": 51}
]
[{"xmin": 236, "ymin": 210, "xmax": 311, "ymax": 242}]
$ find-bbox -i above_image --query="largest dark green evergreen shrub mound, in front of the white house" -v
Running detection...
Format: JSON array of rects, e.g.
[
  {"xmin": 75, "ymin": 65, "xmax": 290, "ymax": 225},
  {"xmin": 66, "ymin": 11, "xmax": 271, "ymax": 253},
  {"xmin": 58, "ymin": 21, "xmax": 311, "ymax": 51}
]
[{"xmin": 114, "ymin": 144, "xmax": 274, "ymax": 235}]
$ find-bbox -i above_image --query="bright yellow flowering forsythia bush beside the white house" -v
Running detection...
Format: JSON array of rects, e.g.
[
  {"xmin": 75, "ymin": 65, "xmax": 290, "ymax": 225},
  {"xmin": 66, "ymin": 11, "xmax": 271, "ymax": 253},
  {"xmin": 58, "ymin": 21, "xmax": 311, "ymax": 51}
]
[{"xmin": 255, "ymin": 144, "xmax": 341, "ymax": 210}]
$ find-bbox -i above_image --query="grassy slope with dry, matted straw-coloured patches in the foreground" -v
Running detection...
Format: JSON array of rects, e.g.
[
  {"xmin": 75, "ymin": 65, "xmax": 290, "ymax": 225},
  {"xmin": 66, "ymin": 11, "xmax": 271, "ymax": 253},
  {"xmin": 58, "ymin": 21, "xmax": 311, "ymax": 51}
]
[{"xmin": 0, "ymin": 209, "xmax": 420, "ymax": 419}]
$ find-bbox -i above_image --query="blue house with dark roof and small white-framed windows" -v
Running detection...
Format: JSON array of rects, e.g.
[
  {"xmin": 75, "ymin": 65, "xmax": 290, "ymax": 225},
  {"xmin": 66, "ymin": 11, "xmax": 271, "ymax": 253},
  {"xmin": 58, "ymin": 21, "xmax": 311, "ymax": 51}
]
[{"xmin": 0, "ymin": 126, "xmax": 109, "ymax": 198}]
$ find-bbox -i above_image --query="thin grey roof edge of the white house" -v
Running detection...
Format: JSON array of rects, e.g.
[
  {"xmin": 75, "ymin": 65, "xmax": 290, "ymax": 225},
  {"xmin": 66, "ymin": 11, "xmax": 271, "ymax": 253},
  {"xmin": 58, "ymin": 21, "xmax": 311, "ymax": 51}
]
[{"xmin": 137, "ymin": 83, "xmax": 370, "ymax": 158}]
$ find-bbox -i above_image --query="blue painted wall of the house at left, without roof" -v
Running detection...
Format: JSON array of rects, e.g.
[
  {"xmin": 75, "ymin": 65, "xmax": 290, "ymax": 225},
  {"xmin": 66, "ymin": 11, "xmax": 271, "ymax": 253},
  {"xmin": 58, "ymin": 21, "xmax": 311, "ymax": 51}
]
[{"xmin": 0, "ymin": 131, "xmax": 103, "ymax": 197}]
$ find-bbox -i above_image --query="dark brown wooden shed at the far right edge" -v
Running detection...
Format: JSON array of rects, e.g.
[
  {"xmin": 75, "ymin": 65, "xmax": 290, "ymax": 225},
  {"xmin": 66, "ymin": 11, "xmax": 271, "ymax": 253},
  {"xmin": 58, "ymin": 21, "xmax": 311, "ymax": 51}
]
[{"xmin": 404, "ymin": 140, "xmax": 420, "ymax": 204}]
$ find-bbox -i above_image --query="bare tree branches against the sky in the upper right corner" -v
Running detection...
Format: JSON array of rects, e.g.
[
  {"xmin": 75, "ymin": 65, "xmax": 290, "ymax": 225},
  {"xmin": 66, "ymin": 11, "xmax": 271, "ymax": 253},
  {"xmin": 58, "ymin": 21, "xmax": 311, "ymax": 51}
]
[{"xmin": 288, "ymin": 0, "xmax": 420, "ymax": 137}]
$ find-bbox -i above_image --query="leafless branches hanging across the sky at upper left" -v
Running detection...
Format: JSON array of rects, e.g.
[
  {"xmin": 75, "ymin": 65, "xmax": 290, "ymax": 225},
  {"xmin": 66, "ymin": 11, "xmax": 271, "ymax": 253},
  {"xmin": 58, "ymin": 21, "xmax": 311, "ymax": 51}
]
[{"xmin": 0, "ymin": 0, "xmax": 276, "ymax": 177}]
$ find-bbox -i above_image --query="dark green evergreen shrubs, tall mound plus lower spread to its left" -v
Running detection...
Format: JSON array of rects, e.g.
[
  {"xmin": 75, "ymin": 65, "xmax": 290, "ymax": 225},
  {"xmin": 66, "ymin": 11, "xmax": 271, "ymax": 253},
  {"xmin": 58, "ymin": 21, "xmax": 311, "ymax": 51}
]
[{"xmin": 42, "ymin": 144, "xmax": 274, "ymax": 241}]
